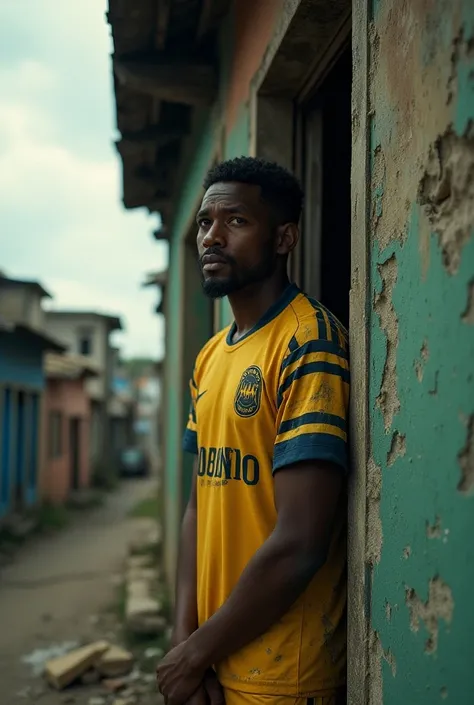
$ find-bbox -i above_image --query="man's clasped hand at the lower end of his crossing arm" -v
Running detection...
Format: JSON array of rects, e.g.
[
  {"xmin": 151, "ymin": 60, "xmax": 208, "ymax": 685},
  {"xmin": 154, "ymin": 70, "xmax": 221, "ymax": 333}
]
[{"xmin": 156, "ymin": 641, "xmax": 206, "ymax": 705}]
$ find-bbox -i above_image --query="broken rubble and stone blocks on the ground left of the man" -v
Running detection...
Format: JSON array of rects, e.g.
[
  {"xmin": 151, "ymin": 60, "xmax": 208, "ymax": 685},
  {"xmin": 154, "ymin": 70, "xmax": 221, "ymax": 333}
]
[{"xmin": 22, "ymin": 527, "xmax": 169, "ymax": 705}]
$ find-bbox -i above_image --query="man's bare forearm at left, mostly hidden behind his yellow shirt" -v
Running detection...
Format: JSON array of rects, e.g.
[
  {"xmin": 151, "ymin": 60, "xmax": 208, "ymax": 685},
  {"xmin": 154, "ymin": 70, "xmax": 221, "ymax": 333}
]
[{"xmin": 171, "ymin": 461, "xmax": 198, "ymax": 646}]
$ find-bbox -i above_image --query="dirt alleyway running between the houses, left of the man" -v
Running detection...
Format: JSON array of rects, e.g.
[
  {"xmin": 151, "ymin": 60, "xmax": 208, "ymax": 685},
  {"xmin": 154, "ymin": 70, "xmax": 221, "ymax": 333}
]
[{"xmin": 0, "ymin": 479, "xmax": 156, "ymax": 705}]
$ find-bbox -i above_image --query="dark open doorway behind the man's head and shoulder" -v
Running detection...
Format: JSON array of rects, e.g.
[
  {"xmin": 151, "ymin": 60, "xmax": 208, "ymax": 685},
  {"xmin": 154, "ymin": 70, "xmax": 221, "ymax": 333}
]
[{"xmin": 300, "ymin": 46, "xmax": 352, "ymax": 327}]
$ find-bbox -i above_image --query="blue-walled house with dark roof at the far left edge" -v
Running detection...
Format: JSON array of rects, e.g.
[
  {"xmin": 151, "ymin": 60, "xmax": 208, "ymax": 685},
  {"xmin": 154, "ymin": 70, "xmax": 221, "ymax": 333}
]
[{"xmin": 0, "ymin": 277, "xmax": 64, "ymax": 522}]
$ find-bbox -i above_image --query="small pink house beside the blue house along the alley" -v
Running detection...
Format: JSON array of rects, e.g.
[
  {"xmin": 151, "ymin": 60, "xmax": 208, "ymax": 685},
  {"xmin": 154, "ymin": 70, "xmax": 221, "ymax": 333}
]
[{"xmin": 41, "ymin": 353, "xmax": 97, "ymax": 504}]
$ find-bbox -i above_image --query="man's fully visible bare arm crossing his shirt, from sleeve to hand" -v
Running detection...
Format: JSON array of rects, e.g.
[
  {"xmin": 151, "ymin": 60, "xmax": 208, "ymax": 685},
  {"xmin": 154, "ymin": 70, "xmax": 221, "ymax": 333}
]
[{"xmin": 157, "ymin": 461, "xmax": 342, "ymax": 705}]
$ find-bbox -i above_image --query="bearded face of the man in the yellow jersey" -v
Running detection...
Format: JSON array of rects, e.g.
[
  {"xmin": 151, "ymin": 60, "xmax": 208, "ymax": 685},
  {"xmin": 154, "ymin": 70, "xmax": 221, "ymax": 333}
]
[{"xmin": 196, "ymin": 182, "xmax": 277, "ymax": 298}]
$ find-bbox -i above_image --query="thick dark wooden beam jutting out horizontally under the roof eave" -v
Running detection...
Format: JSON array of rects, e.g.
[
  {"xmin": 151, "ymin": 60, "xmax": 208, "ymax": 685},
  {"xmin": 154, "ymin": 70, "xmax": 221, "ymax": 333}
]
[{"xmin": 114, "ymin": 59, "xmax": 217, "ymax": 105}]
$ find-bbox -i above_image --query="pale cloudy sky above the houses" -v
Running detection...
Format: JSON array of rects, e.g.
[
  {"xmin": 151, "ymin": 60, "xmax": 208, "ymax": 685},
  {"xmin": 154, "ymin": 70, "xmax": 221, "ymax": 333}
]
[{"xmin": 0, "ymin": 0, "xmax": 167, "ymax": 358}]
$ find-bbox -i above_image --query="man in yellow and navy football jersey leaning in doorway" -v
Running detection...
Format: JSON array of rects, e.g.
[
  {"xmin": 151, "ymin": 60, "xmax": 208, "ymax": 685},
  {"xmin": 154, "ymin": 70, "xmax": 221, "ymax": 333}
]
[{"xmin": 157, "ymin": 157, "xmax": 349, "ymax": 705}]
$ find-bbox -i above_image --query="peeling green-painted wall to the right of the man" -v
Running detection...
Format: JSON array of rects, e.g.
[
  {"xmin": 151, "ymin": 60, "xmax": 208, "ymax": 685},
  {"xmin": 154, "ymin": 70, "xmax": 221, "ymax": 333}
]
[{"xmin": 366, "ymin": 0, "xmax": 474, "ymax": 705}]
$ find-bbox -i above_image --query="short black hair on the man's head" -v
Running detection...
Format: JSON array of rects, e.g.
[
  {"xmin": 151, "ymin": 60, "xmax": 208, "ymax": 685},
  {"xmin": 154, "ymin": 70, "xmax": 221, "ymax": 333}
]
[{"xmin": 204, "ymin": 157, "xmax": 304, "ymax": 223}]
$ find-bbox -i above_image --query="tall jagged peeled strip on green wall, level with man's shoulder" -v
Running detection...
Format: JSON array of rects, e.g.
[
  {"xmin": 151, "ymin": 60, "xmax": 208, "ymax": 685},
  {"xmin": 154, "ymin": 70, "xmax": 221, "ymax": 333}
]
[{"xmin": 374, "ymin": 254, "xmax": 400, "ymax": 432}]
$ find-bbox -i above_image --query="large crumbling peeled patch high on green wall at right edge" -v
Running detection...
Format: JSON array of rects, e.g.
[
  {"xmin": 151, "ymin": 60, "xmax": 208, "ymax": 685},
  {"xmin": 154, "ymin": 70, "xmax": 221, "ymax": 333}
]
[{"xmin": 418, "ymin": 128, "xmax": 474, "ymax": 274}]
